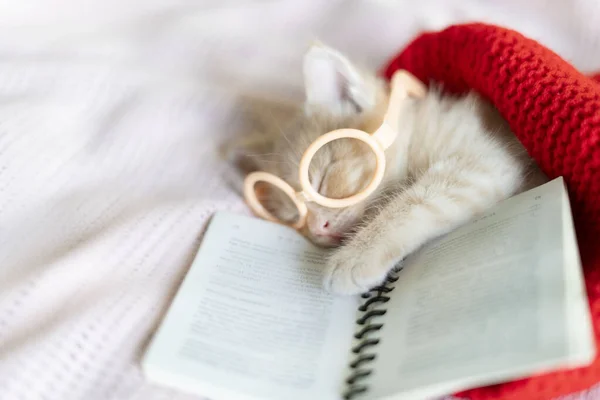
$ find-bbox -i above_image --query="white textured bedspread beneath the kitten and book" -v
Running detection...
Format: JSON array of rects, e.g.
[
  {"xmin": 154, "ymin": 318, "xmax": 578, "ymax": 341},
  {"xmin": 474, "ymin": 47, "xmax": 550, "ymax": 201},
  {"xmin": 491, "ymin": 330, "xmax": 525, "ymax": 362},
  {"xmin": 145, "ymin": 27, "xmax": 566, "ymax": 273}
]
[{"xmin": 0, "ymin": 0, "xmax": 600, "ymax": 400}]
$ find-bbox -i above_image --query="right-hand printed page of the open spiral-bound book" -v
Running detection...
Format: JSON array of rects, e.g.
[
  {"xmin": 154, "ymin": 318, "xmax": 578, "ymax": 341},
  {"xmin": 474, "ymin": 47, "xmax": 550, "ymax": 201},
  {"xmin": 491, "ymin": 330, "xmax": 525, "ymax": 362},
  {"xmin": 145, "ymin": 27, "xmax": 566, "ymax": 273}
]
[{"xmin": 368, "ymin": 178, "xmax": 595, "ymax": 400}]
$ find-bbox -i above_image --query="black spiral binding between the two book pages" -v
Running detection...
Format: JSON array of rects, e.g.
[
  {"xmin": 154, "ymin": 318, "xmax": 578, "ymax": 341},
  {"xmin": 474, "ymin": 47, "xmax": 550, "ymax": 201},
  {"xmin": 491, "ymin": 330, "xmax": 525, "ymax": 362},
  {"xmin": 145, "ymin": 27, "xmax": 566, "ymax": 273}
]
[{"xmin": 344, "ymin": 266, "xmax": 403, "ymax": 400}]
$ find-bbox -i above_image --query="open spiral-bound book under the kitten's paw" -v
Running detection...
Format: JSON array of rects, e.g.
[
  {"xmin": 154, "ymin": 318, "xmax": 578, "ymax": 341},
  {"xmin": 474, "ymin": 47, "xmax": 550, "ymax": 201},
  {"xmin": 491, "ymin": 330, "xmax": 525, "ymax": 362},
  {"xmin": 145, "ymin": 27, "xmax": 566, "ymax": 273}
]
[{"xmin": 142, "ymin": 178, "xmax": 596, "ymax": 400}]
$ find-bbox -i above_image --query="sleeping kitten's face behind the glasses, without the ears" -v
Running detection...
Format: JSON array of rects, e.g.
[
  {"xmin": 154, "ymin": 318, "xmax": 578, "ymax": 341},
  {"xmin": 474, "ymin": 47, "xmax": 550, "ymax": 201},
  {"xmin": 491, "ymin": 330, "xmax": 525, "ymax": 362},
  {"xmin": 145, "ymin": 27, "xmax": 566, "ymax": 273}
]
[{"xmin": 262, "ymin": 114, "xmax": 375, "ymax": 247}]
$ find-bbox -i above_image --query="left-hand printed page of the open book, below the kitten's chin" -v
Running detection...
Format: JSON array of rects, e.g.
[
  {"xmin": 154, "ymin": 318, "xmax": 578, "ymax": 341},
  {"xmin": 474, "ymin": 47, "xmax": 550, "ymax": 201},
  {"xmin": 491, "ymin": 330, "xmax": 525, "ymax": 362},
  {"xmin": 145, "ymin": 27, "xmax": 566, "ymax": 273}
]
[{"xmin": 143, "ymin": 213, "xmax": 357, "ymax": 400}]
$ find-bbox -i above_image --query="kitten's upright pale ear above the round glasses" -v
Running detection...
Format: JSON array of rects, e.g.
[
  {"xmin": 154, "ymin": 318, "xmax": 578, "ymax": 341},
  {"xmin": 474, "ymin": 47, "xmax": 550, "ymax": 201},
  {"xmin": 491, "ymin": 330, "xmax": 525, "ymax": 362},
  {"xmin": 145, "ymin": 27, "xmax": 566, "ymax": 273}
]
[{"xmin": 303, "ymin": 43, "xmax": 375, "ymax": 114}]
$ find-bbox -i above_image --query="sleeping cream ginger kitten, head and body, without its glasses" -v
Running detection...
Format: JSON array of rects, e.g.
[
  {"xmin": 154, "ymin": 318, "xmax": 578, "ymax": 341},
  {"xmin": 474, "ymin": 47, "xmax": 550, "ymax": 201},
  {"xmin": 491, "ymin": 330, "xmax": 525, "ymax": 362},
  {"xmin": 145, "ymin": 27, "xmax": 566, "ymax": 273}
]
[{"xmin": 223, "ymin": 45, "xmax": 546, "ymax": 294}]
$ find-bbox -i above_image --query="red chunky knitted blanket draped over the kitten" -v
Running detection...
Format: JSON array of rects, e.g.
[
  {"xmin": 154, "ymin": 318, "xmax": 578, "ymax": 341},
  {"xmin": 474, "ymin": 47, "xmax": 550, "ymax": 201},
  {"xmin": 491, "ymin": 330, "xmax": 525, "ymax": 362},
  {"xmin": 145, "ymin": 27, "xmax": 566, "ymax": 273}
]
[{"xmin": 384, "ymin": 24, "xmax": 600, "ymax": 400}]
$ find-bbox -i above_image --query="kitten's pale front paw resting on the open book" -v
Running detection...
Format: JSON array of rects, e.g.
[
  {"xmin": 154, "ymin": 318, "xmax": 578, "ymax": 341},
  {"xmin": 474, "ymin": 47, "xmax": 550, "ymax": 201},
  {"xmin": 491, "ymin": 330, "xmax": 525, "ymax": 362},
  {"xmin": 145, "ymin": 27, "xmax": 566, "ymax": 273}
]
[{"xmin": 323, "ymin": 246, "xmax": 393, "ymax": 295}]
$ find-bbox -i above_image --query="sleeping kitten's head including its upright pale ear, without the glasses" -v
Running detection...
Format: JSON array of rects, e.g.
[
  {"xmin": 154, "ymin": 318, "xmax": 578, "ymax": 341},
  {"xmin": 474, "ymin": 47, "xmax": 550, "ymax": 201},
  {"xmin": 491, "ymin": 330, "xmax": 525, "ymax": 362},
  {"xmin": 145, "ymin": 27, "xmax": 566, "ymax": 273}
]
[{"xmin": 245, "ymin": 43, "xmax": 387, "ymax": 247}]
